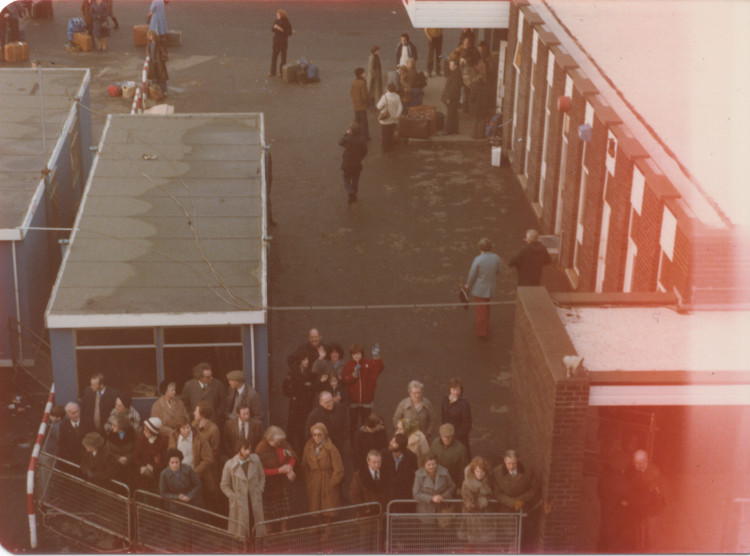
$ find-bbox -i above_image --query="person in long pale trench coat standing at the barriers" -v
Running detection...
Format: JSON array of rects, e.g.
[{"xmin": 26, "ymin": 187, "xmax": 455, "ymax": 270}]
[{"xmin": 219, "ymin": 442, "xmax": 266, "ymax": 537}]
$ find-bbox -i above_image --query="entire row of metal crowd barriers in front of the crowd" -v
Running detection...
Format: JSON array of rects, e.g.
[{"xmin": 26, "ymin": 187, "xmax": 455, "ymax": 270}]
[{"xmin": 34, "ymin": 452, "xmax": 524, "ymax": 554}]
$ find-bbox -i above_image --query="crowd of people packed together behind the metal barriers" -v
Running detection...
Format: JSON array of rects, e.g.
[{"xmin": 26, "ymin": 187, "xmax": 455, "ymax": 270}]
[{"xmin": 46, "ymin": 329, "xmax": 537, "ymax": 534}]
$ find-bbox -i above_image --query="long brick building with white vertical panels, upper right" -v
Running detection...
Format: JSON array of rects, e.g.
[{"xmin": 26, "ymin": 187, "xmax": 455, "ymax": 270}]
[{"xmin": 502, "ymin": 0, "xmax": 750, "ymax": 306}]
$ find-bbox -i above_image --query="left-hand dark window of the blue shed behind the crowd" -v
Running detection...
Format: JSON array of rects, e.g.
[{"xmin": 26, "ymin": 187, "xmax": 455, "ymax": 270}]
[{"xmin": 76, "ymin": 348, "xmax": 159, "ymax": 398}]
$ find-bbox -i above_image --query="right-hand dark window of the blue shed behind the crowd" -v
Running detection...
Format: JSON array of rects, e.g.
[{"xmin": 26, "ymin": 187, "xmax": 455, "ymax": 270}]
[{"xmin": 164, "ymin": 346, "xmax": 243, "ymax": 393}]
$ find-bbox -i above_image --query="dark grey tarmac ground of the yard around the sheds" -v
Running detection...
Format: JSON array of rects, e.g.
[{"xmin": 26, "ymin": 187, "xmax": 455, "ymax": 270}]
[{"xmin": 0, "ymin": 0, "xmax": 565, "ymax": 551}]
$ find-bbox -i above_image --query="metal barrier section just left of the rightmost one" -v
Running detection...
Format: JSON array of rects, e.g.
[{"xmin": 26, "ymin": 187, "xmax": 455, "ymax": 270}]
[{"xmin": 253, "ymin": 502, "xmax": 383, "ymax": 554}]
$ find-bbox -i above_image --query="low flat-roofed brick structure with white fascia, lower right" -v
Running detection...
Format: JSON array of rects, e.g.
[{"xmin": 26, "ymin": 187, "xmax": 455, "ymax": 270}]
[{"xmin": 511, "ymin": 287, "xmax": 750, "ymax": 553}]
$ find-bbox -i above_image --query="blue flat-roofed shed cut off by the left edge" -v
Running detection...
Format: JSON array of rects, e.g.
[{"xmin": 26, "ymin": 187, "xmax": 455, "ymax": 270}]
[{"xmin": 0, "ymin": 68, "xmax": 92, "ymax": 372}]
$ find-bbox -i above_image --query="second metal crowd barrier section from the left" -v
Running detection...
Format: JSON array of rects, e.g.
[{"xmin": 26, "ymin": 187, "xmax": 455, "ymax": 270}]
[{"xmin": 134, "ymin": 490, "xmax": 248, "ymax": 553}]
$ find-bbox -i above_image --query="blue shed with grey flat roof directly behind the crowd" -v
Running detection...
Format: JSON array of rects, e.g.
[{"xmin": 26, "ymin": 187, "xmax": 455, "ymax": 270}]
[{"xmin": 46, "ymin": 114, "xmax": 267, "ymax": 412}]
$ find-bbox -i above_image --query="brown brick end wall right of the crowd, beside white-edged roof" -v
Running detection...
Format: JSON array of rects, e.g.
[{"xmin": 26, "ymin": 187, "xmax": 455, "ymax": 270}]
[{"xmin": 511, "ymin": 287, "xmax": 589, "ymax": 552}]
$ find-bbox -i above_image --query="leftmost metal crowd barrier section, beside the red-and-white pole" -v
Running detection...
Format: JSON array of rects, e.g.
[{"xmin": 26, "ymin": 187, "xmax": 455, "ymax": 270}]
[{"xmin": 34, "ymin": 452, "xmax": 131, "ymax": 552}]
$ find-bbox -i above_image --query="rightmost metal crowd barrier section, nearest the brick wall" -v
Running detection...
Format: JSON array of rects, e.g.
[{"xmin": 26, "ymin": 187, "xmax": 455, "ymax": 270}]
[{"xmin": 385, "ymin": 500, "xmax": 524, "ymax": 554}]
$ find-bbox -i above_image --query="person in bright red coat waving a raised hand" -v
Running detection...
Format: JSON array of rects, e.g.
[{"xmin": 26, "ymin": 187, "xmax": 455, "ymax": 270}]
[{"xmin": 341, "ymin": 344, "xmax": 385, "ymax": 440}]
